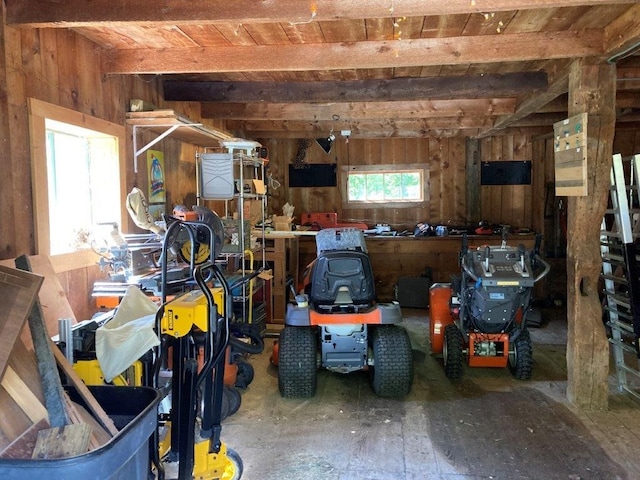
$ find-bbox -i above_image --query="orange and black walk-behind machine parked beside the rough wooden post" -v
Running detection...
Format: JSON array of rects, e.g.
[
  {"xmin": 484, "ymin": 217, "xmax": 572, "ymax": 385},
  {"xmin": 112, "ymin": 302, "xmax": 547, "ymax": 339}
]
[{"xmin": 429, "ymin": 229, "xmax": 550, "ymax": 380}]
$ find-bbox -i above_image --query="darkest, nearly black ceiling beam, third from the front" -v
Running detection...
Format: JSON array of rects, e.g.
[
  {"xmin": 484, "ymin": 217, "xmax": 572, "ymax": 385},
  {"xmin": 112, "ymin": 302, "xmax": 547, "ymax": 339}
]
[{"xmin": 164, "ymin": 71, "xmax": 547, "ymax": 103}]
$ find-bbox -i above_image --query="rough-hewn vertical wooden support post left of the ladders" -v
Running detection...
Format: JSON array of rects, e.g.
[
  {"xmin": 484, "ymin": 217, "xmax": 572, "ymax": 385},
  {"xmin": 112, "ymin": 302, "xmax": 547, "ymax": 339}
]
[{"xmin": 567, "ymin": 59, "xmax": 616, "ymax": 410}]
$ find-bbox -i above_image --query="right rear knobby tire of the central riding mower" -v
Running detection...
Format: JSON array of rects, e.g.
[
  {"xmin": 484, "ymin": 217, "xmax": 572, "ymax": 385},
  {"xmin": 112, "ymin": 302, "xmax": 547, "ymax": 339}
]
[{"xmin": 369, "ymin": 325, "xmax": 413, "ymax": 398}]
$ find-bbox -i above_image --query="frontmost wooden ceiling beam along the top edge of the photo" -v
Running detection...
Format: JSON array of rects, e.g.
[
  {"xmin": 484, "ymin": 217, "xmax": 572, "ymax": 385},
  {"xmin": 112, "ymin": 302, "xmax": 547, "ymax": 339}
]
[{"xmin": 6, "ymin": 0, "xmax": 634, "ymax": 28}]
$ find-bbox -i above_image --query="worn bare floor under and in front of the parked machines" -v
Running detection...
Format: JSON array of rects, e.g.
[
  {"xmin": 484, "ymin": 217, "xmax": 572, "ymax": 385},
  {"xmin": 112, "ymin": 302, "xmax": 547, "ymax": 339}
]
[{"xmin": 222, "ymin": 309, "xmax": 640, "ymax": 480}]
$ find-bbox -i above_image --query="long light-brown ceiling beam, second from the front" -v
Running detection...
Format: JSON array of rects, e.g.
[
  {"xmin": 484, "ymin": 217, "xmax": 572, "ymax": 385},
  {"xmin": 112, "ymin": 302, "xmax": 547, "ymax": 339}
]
[{"xmin": 101, "ymin": 29, "xmax": 603, "ymax": 74}]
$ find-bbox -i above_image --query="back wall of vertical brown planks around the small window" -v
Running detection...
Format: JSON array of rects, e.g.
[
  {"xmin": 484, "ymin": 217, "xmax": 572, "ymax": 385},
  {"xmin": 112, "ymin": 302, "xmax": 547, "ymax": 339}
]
[{"xmin": 259, "ymin": 135, "xmax": 537, "ymax": 231}]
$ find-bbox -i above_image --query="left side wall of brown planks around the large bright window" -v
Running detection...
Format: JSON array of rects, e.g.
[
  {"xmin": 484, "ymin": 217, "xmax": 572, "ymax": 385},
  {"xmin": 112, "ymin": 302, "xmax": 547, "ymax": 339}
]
[{"xmin": 0, "ymin": 24, "xmax": 221, "ymax": 320}]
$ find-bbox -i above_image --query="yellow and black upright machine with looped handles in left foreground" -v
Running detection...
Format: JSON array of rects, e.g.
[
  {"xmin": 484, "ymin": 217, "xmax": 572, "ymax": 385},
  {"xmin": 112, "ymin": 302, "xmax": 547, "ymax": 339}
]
[{"xmin": 153, "ymin": 216, "xmax": 243, "ymax": 480}]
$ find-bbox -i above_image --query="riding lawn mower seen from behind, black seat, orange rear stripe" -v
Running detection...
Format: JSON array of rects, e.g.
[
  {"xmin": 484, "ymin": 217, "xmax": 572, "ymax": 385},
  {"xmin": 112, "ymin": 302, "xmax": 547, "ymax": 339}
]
[{"xmin": 272, "ymin": 228, "xmax": 413, "ymax": 397}]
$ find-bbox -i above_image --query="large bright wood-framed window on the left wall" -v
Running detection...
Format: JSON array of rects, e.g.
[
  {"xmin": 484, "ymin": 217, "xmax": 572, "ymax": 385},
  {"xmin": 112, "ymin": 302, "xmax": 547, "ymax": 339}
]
[{"xmin": 29, "ymin": 99, "xmax": 124, "ymax": 266}]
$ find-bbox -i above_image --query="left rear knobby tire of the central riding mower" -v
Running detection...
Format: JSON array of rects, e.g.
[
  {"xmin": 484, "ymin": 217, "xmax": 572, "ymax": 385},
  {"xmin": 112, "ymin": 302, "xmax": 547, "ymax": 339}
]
[{"xmin": 278, "ymin": 326, "xmax": 318, "ymax": 398}]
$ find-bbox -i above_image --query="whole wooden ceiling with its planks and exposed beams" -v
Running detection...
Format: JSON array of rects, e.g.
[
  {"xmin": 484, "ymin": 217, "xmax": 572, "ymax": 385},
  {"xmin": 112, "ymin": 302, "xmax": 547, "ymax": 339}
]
[{"xmin": 6, "ymin": 0, "xmax": 640, "ymax": 138}]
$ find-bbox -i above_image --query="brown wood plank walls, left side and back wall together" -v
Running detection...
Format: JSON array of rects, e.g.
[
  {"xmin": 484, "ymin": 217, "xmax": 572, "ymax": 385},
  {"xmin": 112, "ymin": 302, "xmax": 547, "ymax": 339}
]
[{"xmin": 0, "ymin": 16, "xmax": 640, "ymax": 320}]
